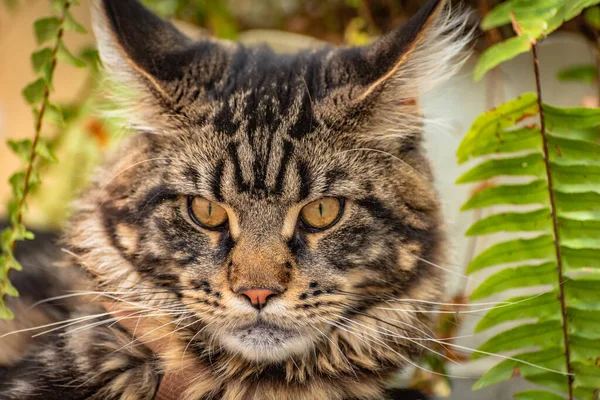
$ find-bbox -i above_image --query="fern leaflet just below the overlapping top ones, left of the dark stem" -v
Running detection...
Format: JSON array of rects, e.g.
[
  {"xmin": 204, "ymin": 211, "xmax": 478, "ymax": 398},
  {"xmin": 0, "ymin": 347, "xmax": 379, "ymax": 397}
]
[{"xmin": 456, "ymin": 153, "xmax": 546, "ymax": 183}]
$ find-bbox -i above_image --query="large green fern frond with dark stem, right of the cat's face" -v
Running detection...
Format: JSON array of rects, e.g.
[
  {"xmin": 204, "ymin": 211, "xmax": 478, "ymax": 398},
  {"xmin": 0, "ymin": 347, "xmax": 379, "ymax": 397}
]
[{"xmin": 457, "ymin": 93, "xmax": 600, "ymax": 400}]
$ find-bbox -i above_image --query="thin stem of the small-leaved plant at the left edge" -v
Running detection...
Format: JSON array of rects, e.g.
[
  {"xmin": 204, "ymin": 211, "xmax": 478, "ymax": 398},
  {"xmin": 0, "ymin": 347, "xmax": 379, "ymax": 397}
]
[{"xmin": 0, "ymin": 0, "xmax": 71, "ymax": 296}]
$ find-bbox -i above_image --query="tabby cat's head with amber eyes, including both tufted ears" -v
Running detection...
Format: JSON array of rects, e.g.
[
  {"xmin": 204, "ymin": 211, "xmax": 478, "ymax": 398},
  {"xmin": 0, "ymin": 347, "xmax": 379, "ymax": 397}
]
[{"xmin": 70, "ymin": 0, "xmax": 462, "ymax": 362}]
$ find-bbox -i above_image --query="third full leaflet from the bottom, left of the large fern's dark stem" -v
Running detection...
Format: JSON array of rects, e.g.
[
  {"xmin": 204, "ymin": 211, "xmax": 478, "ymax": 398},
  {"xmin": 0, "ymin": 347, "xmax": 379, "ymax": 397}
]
[{"xmin": 475, "ymin": 292, "xmax": 561, "ymax": 333}]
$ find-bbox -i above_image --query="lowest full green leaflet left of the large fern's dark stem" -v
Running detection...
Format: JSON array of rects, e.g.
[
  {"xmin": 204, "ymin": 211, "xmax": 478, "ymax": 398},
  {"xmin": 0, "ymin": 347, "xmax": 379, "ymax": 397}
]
[{"xmin": 473, "ymin": 348, "xmax": 566, "ymax": 390}]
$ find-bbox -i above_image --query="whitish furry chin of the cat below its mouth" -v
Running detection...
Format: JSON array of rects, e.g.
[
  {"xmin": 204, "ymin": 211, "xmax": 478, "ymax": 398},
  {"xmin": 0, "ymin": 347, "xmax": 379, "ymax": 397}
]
[{"xmin": 220, "ymin": 326, "xmax": 314, "ymax": 362}]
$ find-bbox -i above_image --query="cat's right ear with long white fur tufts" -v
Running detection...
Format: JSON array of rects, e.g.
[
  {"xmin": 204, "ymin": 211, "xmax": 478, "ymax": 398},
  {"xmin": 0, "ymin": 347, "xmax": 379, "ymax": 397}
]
[{"xmin": 330, "ymin": 0, "xmax": 471, "ymax": 141}]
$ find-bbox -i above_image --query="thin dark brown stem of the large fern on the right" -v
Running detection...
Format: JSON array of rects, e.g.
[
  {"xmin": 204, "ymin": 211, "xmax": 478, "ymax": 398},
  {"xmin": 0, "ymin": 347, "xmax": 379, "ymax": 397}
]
[{"xmin": 531, "ymin": 43, "xmax": 574, "ymax": 400}]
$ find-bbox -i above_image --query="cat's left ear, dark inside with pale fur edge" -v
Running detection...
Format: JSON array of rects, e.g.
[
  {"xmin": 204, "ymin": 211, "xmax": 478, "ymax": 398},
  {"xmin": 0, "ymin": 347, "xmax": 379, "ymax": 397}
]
[{"xmin": 92, "ymin": 0, "xmax": 230, "ymax": 123}]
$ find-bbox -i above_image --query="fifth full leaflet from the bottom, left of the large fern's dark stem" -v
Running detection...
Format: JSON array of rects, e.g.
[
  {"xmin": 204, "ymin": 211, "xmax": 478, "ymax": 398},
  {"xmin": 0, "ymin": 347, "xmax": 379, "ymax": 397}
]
[{"xmin": 467, "ymin": 235, "xmax": 555, "ymax": 274}]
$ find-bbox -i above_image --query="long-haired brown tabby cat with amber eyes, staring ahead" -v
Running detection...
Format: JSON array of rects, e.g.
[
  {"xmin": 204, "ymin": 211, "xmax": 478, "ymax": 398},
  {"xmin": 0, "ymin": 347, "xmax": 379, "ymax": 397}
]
[{"xmin": 0, "ymin": 0, "xmax": 469, "ymax": 400}]
